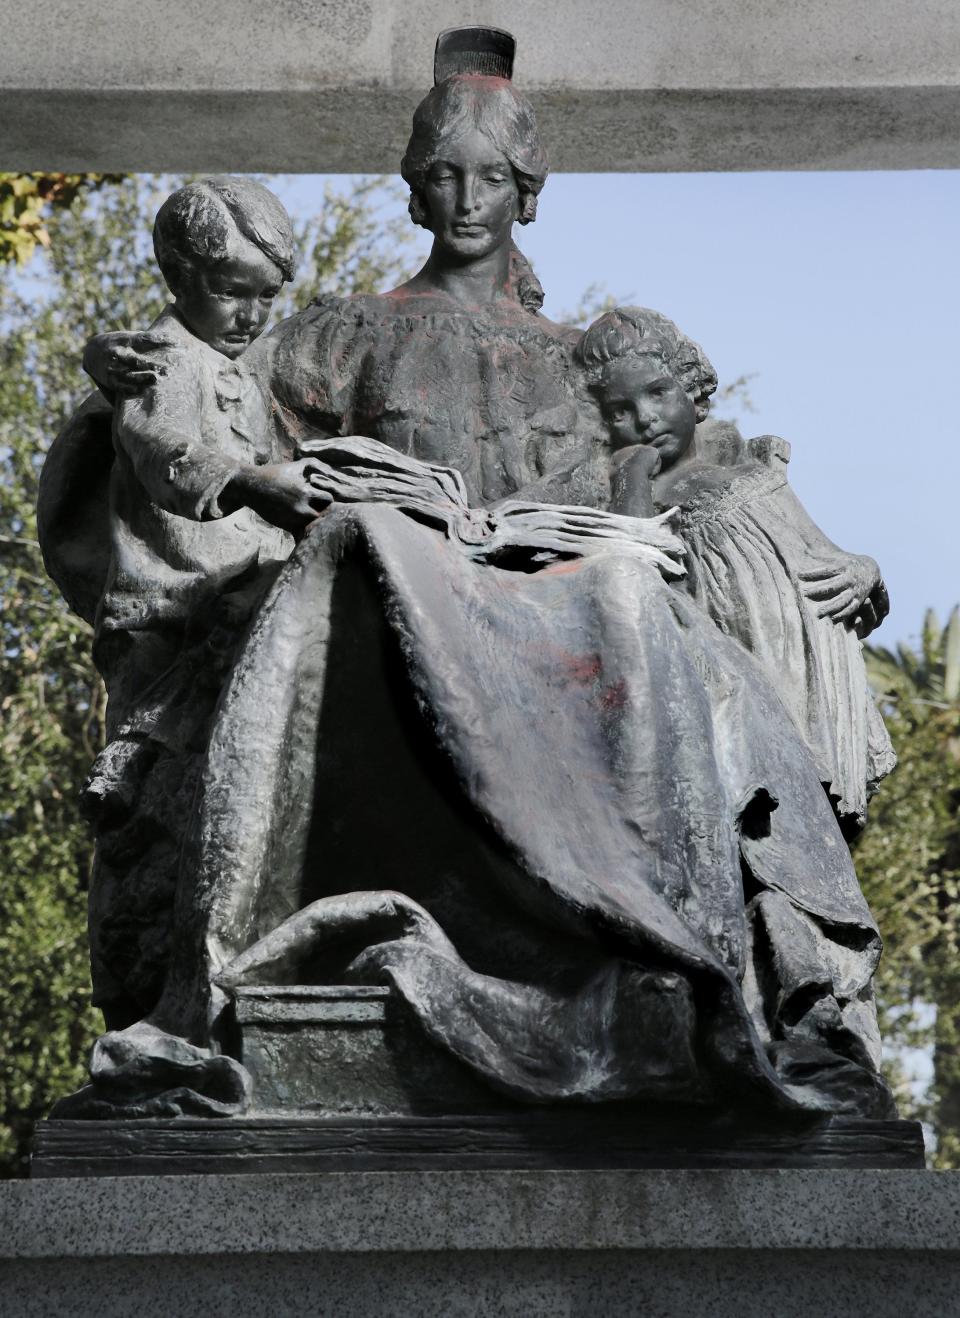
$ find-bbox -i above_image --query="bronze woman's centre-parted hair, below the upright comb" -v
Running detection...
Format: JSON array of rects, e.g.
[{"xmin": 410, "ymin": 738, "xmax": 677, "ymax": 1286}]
[{"xmin": 400, "ymin": 74, "xmax": 547, "ymax": 228}]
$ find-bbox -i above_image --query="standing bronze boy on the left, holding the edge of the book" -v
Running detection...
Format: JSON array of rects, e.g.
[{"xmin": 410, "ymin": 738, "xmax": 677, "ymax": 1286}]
[{"xmin": 47, "ymin": 178, "xmax": 328, "ymax": 1028}]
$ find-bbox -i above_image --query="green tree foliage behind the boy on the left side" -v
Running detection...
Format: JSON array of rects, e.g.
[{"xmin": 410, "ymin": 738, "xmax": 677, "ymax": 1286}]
[{"xmin": 0, "ymin": 177, "xmax": 409, "ymax": 1174}]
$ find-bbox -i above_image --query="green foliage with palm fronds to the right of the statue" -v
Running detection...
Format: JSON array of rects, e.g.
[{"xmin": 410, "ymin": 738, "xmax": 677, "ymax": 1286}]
[{"xmin": 855, "ymin": 606, "xmax": 960, "ymax": 1168}]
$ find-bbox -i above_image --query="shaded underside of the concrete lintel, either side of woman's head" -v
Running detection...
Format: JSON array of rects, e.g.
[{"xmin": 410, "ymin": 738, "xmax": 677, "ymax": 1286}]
[{"xmin": 0, "ymin": 87, "xmax": 960, "ymax": 174}]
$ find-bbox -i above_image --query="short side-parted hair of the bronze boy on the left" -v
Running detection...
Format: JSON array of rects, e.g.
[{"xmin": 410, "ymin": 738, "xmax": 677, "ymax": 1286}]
[{"xmin": 153, "ymin": 175, "xmax": 295, "ymax": 289}]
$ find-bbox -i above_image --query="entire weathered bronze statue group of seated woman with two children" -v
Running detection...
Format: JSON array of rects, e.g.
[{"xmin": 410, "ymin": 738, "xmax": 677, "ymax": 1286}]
[{"xmin": 33, "ymin": 30, "xmax": 912, "ymax": 1156}]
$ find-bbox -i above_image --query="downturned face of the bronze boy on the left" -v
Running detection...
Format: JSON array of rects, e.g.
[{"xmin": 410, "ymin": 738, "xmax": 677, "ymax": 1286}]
[{"xmin": 177, "ymin": 233, "xmax": 284, "ymax": 360}]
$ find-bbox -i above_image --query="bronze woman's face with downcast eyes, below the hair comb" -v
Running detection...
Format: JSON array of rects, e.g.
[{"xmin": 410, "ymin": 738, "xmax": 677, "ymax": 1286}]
[{"xmin": 423, "ymin": 128, "xmax": 520, "ymax": 261}]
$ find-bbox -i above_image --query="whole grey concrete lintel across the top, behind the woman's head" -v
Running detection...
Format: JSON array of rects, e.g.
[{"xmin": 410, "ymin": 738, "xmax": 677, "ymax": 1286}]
[{"xmin": 0, "ymin": 0, "xmax": 960, "ymax": 173}]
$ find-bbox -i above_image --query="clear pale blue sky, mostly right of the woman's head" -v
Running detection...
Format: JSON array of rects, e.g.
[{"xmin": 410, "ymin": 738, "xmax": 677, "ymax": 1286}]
[{"xmin": 274, "ymin": 170, "xmax": 960, "ymax": 645}]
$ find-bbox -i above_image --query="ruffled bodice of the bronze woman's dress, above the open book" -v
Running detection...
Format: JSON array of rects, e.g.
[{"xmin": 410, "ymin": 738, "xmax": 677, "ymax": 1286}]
[{"xmin": 255, "ymin": 293, "xmax": 584, "ymax": 503}]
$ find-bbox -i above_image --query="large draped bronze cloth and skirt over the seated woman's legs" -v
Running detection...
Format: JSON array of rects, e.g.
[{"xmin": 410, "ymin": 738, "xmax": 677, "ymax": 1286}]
[{"xmin": 154, "ymin": 505, "xmax": 889, "ymax": 1114}]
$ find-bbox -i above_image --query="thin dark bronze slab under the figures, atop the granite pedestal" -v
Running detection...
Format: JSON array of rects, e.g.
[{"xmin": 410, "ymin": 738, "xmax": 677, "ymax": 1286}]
[{"xmin": 30, "ymin": 1104, "xmax": 923, "ymax": 1178}]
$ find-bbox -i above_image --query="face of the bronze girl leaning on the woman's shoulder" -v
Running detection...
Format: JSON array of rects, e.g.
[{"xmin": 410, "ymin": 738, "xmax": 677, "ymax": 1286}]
[{"xmin": 599, "ymin": 356, "xmax": 696, "ymax": 471}]
